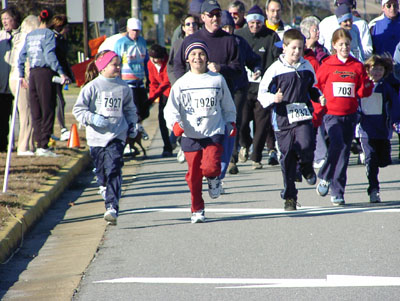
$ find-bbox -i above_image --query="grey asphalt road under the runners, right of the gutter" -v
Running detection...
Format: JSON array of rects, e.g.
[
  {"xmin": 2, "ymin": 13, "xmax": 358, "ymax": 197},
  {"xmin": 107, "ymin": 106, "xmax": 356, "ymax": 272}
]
[{"xmin": 73, "ymin": 130, "xmax": 400, "ymax": 301}]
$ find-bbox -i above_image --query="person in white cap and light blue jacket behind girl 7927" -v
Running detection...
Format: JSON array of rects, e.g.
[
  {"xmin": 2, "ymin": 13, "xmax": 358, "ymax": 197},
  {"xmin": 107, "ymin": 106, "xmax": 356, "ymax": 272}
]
[{"xmin": 114, "ymin": 18, "xmax": 150, "ymax": 121}]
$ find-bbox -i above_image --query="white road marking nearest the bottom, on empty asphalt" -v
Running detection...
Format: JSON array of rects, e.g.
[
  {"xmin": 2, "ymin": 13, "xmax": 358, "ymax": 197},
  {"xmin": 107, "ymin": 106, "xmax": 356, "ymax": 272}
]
[{"xmin": 93, "ymin": 275, "xmax": 400, "ymax": 288}]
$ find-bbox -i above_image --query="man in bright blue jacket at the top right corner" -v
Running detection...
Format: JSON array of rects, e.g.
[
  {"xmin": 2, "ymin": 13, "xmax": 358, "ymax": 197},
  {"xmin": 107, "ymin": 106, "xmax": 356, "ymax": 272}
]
[{"xmin": 371, "ymin": 0, "xmax": 400, "ymax": 56}]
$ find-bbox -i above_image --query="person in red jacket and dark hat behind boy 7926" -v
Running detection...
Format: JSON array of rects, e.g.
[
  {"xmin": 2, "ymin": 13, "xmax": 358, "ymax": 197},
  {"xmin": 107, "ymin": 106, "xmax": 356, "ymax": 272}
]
[{"xmin": 147, "ymin": 44, "xmax": 172, "ymax": 157}]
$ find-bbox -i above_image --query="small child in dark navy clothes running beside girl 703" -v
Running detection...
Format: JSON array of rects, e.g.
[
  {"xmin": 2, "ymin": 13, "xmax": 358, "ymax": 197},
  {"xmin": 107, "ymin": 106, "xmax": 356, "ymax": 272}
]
[{"xmin": 359, "ymin": 55, "xmax": 400, "ymax": 203}]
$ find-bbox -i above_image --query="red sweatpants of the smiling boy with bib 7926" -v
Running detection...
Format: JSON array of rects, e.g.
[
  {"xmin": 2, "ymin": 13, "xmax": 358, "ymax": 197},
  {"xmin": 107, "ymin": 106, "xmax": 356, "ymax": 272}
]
[{"xmin": 185, "ymin": 143, "xmax": 222, "ymax": 212}]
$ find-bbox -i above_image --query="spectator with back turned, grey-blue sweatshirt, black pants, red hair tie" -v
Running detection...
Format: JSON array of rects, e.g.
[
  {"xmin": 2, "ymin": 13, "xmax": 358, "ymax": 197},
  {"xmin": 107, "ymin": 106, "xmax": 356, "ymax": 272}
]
[{"xmin": 18, "ymin": 9, "xmax": 70, "ymax": 157}]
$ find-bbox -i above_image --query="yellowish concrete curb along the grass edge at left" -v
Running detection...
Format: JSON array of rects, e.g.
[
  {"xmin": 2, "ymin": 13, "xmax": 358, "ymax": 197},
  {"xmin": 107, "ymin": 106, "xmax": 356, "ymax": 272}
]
[{"xmin": 0, "ymin": 150, "xmax": 91, "ymax": 263}]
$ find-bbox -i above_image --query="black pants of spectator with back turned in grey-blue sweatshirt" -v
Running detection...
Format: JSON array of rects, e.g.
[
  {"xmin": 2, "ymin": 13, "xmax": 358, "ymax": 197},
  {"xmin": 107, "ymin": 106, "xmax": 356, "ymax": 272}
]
[{"xmin": 29, "ymin": 68, "xmax": 57, "ymax": 148}]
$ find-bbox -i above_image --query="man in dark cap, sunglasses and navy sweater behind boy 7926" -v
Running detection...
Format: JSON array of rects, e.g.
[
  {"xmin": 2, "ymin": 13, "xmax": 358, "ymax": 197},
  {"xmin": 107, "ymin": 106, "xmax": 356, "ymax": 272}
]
[{"xmin": 174, "ymin": 0, "xmax": 242, "ymax": 92}]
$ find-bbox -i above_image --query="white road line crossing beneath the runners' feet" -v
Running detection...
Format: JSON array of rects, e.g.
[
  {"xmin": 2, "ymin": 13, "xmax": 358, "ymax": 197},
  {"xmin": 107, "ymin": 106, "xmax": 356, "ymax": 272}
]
[{"xmin": 126, "ymin": 206, "xmax": 400, "ymax": 215}]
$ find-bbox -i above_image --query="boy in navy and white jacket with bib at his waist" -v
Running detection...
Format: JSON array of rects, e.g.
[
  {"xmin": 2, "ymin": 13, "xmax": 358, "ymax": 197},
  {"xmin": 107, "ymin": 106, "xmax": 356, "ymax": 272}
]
[{"xmin": 258, "ymin": 29, "xmax": 325, "ymax": 211}]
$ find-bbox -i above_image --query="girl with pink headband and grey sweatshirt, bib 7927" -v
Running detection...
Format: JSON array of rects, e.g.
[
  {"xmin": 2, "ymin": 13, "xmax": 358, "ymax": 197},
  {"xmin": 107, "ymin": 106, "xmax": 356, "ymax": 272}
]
[{"xmin": 72, "ymin": 50, "xmax": 137, "ymax": 225}]
